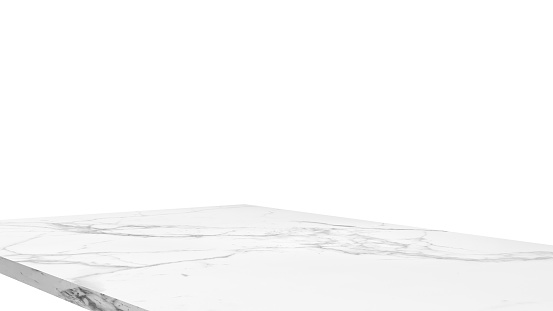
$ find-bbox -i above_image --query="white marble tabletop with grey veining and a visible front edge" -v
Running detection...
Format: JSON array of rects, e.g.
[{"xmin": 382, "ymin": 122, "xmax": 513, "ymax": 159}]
[{"xmin": 0, "ymin": 205, "xmax": 553, "ymax": 311}]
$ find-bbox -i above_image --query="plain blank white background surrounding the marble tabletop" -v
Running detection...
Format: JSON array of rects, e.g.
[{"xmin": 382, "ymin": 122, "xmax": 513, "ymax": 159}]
[{"xmin": 0, "ymin": 0, "xmax": 553, "ymax": 310}]
